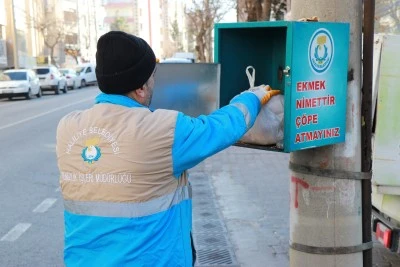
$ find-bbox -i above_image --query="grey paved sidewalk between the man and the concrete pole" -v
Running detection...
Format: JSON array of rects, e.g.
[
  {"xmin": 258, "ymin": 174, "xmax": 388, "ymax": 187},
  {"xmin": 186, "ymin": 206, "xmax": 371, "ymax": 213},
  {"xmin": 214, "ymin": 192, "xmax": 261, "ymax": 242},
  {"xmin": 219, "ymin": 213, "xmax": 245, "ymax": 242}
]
[{"xmin": 190, "ymin": 147, "xmax": 400, "ymax": 267}]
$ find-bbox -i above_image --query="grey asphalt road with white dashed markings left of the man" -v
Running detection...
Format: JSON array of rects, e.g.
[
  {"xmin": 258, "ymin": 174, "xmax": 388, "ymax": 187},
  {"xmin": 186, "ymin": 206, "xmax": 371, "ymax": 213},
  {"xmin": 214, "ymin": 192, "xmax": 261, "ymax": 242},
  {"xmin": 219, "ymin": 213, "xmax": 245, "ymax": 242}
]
[{"xmin": 0, "ymin": 87, "xmax": 99, "ymax": 266}]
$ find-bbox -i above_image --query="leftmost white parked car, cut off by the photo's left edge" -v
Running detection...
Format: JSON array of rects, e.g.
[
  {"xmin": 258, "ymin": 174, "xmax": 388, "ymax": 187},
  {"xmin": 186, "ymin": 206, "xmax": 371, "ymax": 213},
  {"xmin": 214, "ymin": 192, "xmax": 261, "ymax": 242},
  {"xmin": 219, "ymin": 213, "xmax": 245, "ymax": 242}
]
[{"xmin": 0, "ymin": 69, "xmax": 42, "ymax": 100}]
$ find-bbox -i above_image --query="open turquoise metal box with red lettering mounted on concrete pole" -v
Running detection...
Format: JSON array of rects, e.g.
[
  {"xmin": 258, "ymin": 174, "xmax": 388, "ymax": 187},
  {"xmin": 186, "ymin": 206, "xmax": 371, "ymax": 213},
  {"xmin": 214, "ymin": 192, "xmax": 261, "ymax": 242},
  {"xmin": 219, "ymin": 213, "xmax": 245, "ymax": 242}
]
[{"xmin": 214, "ymin": 21, "xmax": 350, "ymax": 152}]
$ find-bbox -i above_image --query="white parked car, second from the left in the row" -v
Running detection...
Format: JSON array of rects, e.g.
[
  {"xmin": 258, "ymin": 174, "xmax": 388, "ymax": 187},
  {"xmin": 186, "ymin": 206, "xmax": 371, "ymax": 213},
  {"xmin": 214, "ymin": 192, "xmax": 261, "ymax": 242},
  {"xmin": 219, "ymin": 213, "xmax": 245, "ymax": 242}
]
[{"xmin": 33, "ymin": 66, "xmax": 68, "ymax": 95}]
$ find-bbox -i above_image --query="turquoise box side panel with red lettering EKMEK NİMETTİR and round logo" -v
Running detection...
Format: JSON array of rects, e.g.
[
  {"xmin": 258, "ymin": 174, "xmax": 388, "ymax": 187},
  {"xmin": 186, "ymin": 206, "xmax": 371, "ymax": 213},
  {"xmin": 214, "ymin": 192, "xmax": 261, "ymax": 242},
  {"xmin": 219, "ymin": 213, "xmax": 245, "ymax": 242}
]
[{"xmin": 285, "ymin": 23, "xmax": 349, "ymax": 151}]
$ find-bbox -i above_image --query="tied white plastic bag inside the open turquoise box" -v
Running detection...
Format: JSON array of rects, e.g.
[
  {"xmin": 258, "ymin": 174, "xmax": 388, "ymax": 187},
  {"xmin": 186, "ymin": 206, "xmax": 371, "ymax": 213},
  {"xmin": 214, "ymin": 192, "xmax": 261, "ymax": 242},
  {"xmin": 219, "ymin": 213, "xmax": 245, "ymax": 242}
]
[{"xmin": 240, "ymin": 66, "xmax": 284, "ymax": 148}]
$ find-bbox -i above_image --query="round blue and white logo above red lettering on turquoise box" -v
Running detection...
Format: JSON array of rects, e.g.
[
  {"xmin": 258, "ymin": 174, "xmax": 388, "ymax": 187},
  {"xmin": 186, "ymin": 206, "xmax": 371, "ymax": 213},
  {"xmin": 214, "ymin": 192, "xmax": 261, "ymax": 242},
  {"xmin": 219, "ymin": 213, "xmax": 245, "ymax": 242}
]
[{"xmin": 308, "ymin": 29, "xmax": 334, "ymax": 74}]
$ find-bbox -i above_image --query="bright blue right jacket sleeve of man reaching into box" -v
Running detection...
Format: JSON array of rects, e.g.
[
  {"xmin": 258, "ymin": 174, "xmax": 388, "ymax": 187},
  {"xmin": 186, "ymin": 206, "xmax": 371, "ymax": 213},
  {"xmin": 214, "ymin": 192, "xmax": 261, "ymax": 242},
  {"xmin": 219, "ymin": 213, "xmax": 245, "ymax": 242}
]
[{"xmin": 172, "ymin": 92, "xmax": 261, "ymax": 177}]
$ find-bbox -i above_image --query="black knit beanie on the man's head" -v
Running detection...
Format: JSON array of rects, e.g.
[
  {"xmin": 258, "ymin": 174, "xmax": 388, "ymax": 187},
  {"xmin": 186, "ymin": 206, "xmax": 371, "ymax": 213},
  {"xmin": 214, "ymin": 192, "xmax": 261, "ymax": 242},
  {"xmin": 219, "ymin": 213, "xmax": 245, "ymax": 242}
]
[{"xmin": 96, "ymin": 31, "xmax": 156, "ymax": 95}]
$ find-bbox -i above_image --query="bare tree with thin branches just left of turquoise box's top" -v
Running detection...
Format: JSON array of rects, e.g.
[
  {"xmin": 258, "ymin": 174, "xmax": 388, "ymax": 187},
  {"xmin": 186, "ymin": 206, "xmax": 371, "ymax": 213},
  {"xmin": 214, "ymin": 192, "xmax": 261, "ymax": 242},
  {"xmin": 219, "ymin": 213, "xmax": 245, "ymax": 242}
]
[{"xmin": 185, "ymin": 0, "xmax": 236, "ymax": 62}]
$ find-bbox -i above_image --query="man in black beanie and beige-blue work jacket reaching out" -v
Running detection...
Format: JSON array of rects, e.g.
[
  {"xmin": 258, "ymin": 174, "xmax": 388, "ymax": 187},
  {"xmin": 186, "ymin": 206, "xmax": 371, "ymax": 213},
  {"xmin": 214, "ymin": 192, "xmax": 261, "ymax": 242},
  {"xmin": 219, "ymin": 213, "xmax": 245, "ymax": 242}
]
[{"xmin": 57, "ymin": 31, "xmax": 279, "ymax": 267}]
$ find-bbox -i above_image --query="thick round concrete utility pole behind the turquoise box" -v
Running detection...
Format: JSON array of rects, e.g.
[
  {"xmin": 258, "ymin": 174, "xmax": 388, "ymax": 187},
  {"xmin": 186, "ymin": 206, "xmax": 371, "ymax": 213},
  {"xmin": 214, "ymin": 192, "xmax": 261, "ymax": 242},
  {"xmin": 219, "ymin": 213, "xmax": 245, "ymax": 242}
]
[{"xmin": 289, "ymin": 0, "xmax": 371, "ymax": 267}]
